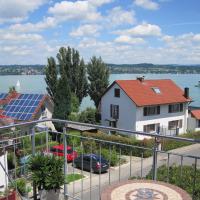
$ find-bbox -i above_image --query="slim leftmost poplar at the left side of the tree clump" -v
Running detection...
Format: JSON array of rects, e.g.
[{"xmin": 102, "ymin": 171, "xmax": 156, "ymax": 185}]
[{"xmin": 45, "ymin": 57, "xmax": 58, "ymax": 102}]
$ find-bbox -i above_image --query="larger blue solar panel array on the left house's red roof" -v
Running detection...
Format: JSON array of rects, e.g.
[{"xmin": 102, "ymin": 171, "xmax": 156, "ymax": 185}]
[{"xmin": 3, "ymin": 94, "xmax": 44, "ymax": 121}]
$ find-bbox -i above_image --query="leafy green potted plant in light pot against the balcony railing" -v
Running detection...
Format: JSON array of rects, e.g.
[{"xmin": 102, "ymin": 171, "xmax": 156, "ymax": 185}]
[{"xmin": 29, "ymin": 154, "xmax": 65, "ymax": 200}]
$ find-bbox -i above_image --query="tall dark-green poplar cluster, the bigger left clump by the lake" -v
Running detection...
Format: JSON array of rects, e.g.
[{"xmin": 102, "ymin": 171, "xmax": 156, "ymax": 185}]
[{"xmin": 45, "ymin": 47, "xmax": 88, "ymax": 126}]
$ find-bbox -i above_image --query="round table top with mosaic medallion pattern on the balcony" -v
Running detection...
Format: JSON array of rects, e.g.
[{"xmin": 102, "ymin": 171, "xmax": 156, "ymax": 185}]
[{"xmin": 101, "ymin": 180, "xmax": 191, "ymax": 200}]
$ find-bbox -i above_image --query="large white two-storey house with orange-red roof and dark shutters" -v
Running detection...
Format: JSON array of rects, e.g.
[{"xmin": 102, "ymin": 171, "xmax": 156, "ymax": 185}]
[{"xmin": 100, "ymin": 77, "xmax": 191, "ymax": 139}]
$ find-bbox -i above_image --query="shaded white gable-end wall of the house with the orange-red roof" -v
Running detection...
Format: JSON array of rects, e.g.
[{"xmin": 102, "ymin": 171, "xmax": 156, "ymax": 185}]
[{"xmin": 101, "ymin": 84, "xmax": 136, "ymax": 134}]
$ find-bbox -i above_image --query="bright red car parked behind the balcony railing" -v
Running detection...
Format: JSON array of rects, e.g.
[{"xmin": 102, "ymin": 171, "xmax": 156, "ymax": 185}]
[{"xmin": 50, "ymin": 144, "xmax": 78, "ymax": 162}]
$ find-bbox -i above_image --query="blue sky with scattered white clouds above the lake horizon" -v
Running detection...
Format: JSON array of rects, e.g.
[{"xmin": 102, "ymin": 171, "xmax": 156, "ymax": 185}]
[{"xmin": 0, "ymin": 0, "xmax": 200, "ymax": 65}]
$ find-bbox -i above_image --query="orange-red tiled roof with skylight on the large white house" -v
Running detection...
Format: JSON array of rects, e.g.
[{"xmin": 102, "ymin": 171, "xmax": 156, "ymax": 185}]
[{"xmin": 115, "ymin": 79, "xmax": 191, "ymax": 106}]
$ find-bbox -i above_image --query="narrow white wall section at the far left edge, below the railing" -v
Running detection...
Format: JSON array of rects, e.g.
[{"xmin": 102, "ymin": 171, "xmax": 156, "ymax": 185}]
[{"xmin": 0, "ymin": 152, "xmax": 8, "ymax": 192}]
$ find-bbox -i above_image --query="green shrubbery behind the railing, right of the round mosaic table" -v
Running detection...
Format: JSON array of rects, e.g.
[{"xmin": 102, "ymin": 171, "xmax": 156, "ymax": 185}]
[{"xmin": 146, "ymin": 165, "xmax": 200, "ymax": 200}]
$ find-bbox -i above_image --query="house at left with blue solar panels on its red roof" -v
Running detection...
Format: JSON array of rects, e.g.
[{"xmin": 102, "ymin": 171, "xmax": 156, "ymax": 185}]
[{"xmin": 0, "ymin": 92, "xmax": 53, "ymax": 129}]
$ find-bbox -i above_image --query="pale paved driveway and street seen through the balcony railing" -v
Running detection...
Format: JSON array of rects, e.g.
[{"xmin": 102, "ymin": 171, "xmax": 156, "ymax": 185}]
[{"xmin": 65, "ymin": 144, "xmax": 200, "ymax": 200}]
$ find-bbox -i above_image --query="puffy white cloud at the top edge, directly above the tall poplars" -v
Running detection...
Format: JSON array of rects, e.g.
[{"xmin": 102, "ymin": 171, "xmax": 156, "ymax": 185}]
[{"xmin": 49, "ymin": 0, "xmax": 111, "ymax": 21}]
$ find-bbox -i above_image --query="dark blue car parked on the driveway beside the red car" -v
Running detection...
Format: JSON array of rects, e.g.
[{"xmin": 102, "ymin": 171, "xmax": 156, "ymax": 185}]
[{"xmin": 73, "ymin": 154, "xmax": 109, "ymax": 173}]
